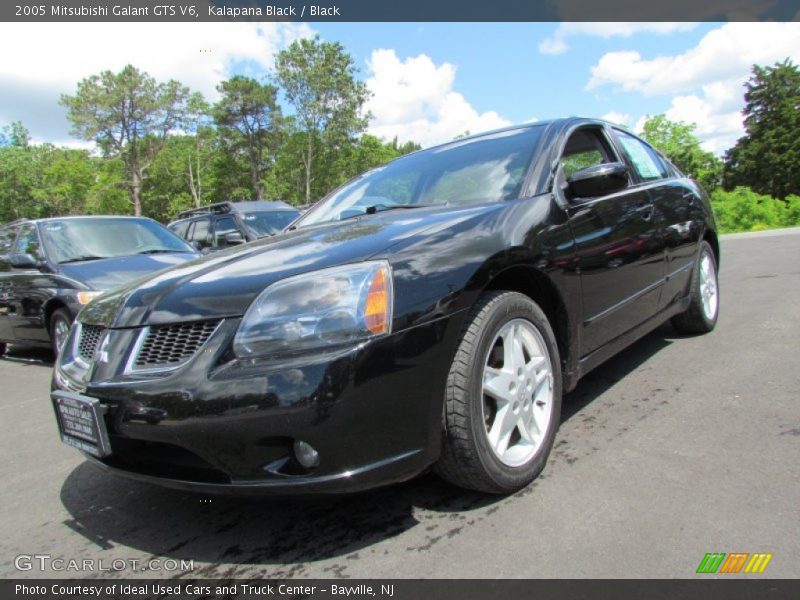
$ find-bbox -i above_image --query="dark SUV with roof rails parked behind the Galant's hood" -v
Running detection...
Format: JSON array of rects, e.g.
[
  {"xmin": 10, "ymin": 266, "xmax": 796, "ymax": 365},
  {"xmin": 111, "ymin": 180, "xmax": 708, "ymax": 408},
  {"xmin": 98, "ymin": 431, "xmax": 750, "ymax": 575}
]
[{"xmin": 167, "ymin": 200, "xmax": 300, "ymax": 252}]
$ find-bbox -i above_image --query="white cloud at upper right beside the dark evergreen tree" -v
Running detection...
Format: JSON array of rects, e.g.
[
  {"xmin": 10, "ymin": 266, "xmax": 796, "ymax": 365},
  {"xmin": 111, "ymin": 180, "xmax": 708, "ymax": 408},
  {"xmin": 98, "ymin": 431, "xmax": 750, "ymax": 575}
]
[{"xmin": 586, "ymin": 22, "xmax": 800, "ymax": 153}]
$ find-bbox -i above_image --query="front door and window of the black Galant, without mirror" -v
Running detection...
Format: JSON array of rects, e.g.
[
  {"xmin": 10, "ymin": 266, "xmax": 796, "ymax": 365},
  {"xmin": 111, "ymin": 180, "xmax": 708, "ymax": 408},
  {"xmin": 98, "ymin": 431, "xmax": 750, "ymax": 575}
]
[{"xmin": 559, "ymin": 126, "xmax": 664, "ymax": 356}]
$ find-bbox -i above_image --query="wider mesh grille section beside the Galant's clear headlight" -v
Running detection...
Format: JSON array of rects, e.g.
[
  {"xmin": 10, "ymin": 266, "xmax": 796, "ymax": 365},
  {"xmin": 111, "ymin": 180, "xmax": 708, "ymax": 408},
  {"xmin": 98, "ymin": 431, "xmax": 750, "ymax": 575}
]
[{"xmin": 133, "ymin": 319, "xmax": 221, "ymax": 369}]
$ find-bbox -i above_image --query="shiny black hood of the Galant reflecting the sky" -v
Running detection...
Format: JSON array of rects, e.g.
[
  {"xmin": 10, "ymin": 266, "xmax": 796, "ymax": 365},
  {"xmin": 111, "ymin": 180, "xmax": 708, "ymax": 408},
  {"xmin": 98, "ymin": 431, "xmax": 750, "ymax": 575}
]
[{"xmin": 80, "ymin": 203, "xmax": 502, "ymax": 328}]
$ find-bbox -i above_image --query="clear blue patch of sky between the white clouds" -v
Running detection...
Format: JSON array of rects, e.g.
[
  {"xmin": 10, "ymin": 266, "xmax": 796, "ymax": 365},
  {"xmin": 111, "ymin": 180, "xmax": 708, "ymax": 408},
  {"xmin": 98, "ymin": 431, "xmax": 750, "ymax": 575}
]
[{"xmin": 315, "ymin": 23, "xmax": 714, "ymax": 123}]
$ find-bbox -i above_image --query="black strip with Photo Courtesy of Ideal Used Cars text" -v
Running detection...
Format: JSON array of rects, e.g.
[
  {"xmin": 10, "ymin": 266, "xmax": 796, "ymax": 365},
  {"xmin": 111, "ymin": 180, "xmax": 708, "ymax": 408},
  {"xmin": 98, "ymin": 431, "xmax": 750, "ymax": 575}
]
[{"xmin": 0, "ymin": 578, "xmax": 800, "ymax": 600}]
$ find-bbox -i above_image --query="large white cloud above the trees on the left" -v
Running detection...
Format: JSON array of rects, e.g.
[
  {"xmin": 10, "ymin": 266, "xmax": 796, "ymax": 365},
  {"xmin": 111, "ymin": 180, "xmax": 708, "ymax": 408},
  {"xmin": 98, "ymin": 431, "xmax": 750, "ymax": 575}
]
[{"xmin": 0, "ymin": 23, "xmax": 312, "ymax": 142}]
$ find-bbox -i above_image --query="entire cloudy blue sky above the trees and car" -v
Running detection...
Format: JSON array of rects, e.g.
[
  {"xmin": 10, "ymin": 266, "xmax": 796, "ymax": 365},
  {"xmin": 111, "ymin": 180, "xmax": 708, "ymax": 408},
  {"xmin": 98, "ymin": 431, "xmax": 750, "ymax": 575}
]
[{"xmin": 0, "ymin": 23, "xmax": 800, "ymax": 153}]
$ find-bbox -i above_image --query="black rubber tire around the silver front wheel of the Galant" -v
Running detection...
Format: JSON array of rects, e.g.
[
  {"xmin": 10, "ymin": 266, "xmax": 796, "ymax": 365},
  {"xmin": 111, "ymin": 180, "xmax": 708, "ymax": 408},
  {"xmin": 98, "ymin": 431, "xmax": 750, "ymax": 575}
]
[{"xmin": 434, "ymin": 291, "xmax": 562, "ymax": 494}]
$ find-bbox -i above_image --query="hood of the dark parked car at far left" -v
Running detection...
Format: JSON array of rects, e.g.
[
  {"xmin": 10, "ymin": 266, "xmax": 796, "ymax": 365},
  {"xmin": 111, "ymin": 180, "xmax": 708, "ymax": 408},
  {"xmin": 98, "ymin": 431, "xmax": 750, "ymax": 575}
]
[{"xmin": 58, "ymin": 252, "xmax": 199, "ymax": 291}]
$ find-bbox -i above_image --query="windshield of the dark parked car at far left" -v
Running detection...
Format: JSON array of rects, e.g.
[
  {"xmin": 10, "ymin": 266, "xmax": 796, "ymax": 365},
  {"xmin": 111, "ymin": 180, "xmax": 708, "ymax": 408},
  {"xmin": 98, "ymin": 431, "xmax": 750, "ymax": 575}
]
[{"xmin": 41, "ymin": 217, "xmax": 194, "ymax": 263}]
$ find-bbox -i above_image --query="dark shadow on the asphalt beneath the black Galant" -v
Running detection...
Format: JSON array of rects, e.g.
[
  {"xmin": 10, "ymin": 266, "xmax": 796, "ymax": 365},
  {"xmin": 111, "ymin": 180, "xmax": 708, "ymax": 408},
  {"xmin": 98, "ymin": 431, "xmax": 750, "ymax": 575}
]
[{"xmin": 61, "ymin": 325, "xmax": 675, "ymax": 577}]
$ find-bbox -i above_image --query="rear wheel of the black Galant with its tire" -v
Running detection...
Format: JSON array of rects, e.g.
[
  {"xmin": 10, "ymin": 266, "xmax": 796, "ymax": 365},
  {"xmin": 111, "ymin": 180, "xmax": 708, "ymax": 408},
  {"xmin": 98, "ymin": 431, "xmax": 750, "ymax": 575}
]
[{"xmin": 672, "ymin": 241, "xmax": 719, "ymax": 333}]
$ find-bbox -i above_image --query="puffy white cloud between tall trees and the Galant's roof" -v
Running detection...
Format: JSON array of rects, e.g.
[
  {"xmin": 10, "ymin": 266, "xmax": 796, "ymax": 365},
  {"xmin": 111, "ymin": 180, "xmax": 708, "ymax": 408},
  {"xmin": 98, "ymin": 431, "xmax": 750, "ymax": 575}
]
[{"xmin": 366, "ymin": 49, "xmax": 509, "ymax": 146}]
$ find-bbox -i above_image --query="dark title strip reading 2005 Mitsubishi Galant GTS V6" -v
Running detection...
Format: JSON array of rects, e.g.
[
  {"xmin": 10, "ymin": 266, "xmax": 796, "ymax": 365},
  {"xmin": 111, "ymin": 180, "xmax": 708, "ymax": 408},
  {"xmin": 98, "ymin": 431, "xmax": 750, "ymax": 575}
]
[{"xmin": 0, "ymin": 0, "xmax": 800, "ymax": 22}]
